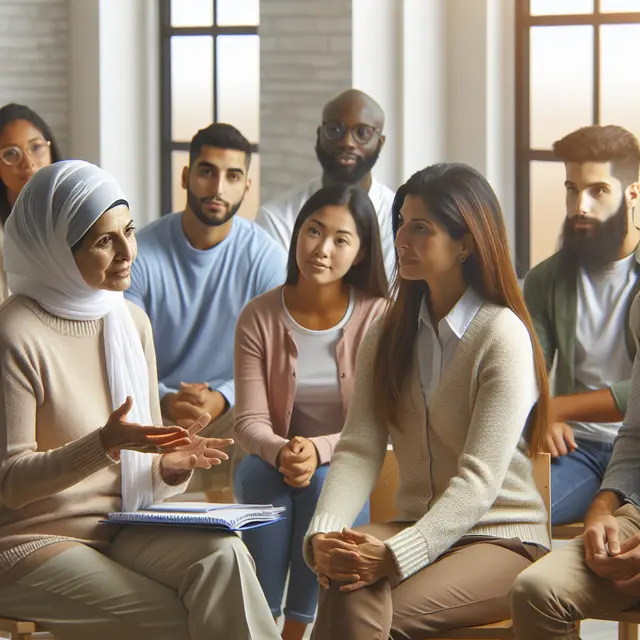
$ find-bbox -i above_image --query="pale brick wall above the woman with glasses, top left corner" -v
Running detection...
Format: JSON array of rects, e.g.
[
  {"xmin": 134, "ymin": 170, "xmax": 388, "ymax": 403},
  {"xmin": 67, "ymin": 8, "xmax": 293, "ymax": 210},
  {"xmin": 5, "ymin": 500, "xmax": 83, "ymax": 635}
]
[{"xmin": 0, "ymin": 0, "xmax": 69, "ymax": 153}]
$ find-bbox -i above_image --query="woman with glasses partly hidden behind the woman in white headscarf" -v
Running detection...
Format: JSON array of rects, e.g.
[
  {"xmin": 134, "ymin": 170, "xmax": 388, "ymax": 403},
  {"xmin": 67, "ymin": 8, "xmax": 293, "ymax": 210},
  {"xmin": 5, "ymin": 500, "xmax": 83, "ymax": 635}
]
[{"xmin": 0, "ymin": 103, "xmax": 62, "ymax": 302}]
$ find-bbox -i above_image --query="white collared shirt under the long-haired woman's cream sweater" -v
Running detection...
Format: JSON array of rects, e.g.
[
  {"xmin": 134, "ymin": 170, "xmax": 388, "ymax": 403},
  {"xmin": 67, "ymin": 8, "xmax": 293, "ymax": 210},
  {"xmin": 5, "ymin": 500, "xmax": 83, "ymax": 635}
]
[{"xmin": 418, "ymin": 287, "xmax": 484, "ymax": 406}]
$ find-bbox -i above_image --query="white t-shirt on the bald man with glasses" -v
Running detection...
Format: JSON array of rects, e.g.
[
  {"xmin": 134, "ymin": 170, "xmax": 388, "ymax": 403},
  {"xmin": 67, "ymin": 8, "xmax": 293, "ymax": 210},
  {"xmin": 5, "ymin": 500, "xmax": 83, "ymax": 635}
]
[{"xmin": 256, "ymin": 178, "xmax": 396, "ymax": 283}]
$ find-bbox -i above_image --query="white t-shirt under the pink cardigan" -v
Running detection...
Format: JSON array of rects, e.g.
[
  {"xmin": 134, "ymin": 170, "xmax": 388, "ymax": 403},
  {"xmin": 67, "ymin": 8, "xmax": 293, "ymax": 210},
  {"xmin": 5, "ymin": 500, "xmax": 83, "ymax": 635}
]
[{"xmin": 282, "ymin": 288, "xmax": 356, "ymax": 438}]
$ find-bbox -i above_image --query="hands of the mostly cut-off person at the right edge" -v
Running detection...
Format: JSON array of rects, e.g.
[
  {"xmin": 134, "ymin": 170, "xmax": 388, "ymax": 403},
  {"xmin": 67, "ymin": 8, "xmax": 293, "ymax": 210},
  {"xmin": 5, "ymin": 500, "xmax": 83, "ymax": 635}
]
[{"xmin": 582, "ymin": 515, "xmax": 640, "ymax": 596}]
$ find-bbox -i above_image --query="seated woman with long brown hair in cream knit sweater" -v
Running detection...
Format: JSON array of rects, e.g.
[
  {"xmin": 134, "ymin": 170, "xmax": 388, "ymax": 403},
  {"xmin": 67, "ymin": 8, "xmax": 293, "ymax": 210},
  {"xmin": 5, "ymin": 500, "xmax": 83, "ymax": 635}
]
[{"xmin": 304, "ymin": 164, "xmax": 549, "ymax": 640}]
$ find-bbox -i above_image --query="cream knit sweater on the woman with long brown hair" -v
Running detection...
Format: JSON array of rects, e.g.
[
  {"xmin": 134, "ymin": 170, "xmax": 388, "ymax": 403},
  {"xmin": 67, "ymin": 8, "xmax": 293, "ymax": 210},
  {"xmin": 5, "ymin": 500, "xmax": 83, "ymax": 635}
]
[{"xmin": 304, "ymin": 303, "xmax": 549, "ymax": 579}]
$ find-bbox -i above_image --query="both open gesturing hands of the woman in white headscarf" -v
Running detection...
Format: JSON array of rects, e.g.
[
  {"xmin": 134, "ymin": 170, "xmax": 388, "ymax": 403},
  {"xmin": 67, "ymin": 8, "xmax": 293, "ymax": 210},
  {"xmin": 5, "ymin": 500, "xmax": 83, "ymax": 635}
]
[{"xmin": 100, "ymin": 397, "xmax": 233, "ymax": 474}]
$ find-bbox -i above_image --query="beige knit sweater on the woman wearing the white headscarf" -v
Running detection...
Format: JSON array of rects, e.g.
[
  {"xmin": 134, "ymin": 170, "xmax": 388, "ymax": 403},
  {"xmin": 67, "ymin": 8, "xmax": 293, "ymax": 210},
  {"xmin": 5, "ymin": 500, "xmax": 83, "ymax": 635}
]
[{"xmin": 0, "ymin": 296, "xmax": 186, "ymax": 581}]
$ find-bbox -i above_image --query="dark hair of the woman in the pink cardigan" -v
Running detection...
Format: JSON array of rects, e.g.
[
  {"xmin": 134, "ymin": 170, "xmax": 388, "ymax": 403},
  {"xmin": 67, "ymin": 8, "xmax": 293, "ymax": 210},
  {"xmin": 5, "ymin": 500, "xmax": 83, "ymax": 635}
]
[{"xmin": 285, "ymin": 184, "xmax": 389, "ymax": 298}]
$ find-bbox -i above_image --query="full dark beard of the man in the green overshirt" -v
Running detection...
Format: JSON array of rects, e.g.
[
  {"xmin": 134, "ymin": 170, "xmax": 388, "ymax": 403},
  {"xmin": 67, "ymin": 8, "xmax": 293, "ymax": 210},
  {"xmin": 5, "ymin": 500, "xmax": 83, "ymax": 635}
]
[{"xmin": 559, "ymin": 198, "xmax": 629, "ymax": 273}]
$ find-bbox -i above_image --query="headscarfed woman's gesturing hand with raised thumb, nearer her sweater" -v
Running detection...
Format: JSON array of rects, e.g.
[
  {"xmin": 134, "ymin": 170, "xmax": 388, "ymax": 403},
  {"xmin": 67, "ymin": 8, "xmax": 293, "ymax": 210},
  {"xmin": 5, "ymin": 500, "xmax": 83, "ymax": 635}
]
[{"xmin": 100, "ymin": 397, "xmax": 194, "ymax": 457}]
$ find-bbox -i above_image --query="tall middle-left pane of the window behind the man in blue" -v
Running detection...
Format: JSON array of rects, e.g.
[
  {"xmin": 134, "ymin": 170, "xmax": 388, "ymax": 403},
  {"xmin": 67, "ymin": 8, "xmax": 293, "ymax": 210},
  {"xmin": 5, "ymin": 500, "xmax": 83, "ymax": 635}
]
[{"xmin": 171, "ymin": 36, "xmax": 213, "ymax": 141}]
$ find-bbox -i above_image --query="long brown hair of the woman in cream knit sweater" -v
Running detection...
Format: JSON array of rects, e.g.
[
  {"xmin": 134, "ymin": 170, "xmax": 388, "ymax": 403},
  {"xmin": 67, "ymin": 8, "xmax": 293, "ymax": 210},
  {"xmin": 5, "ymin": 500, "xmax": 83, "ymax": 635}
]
[{"xmin": 373, "ymin": 164, "xmax": 549, "ymax": 453}]
